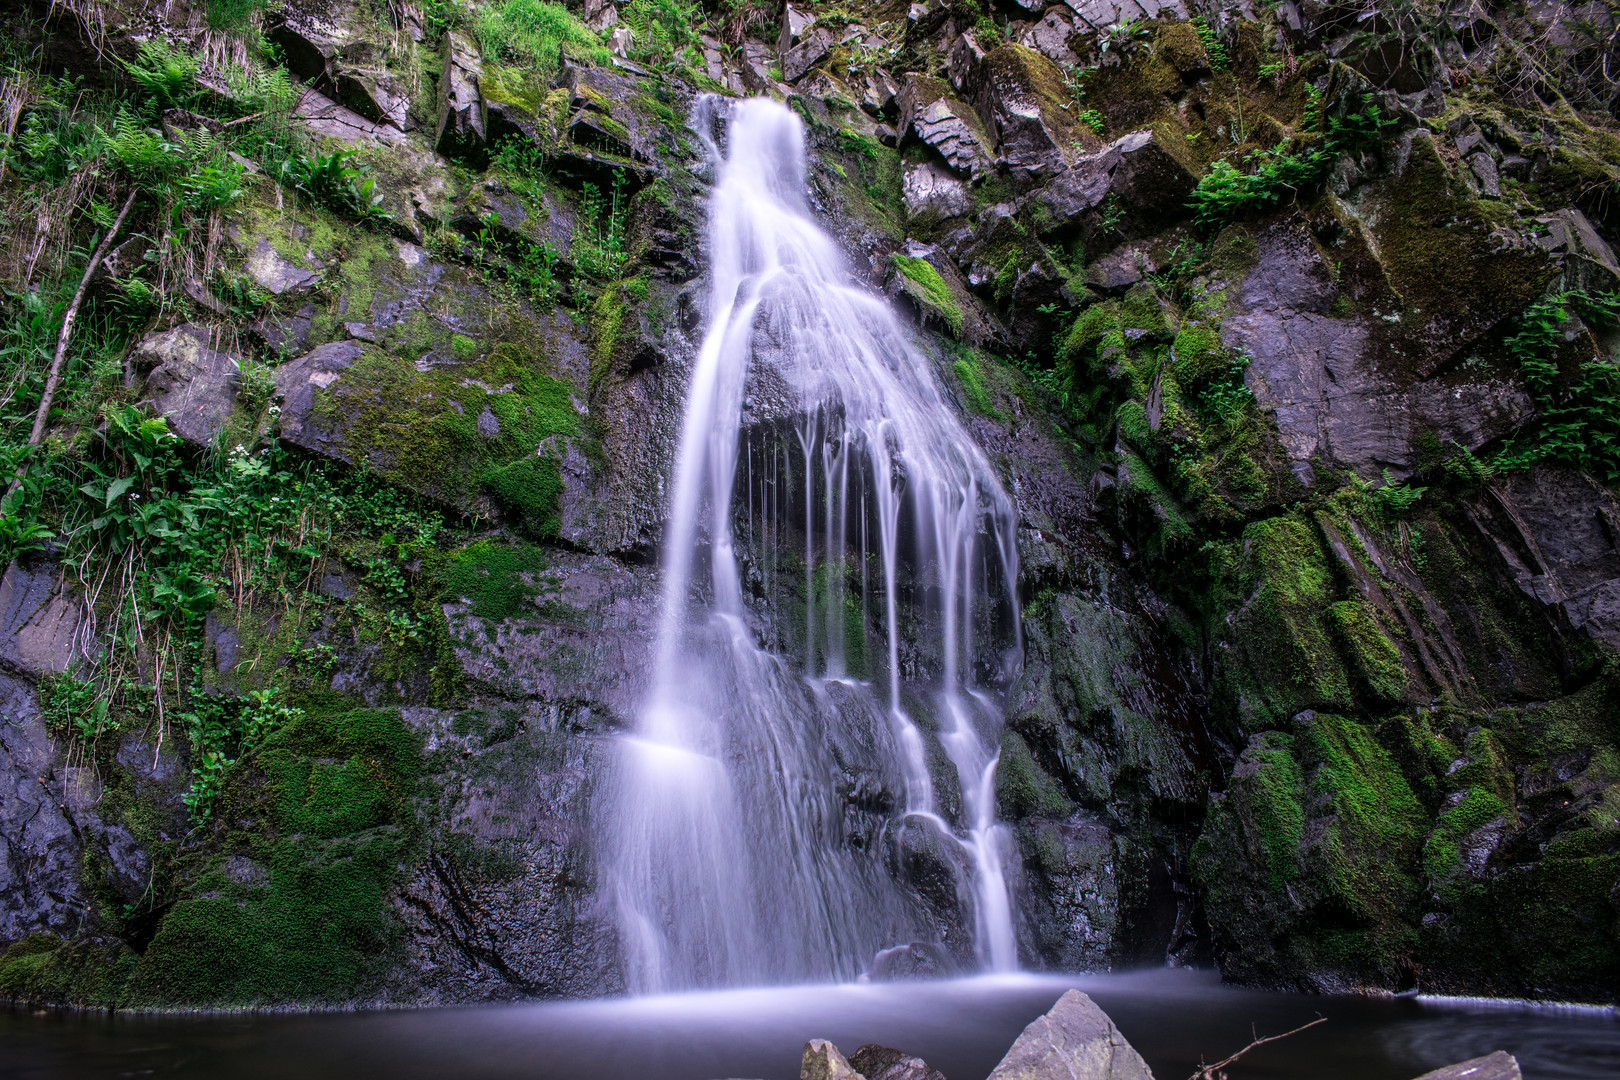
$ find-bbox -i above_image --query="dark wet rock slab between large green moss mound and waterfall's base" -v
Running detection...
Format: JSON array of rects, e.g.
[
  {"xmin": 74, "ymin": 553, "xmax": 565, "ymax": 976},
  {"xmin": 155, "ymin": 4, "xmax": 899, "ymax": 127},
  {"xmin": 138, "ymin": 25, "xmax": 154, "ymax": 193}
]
[{"xmin": 390, "ymin": 698, "xmax": 624, "ymax": 1006}]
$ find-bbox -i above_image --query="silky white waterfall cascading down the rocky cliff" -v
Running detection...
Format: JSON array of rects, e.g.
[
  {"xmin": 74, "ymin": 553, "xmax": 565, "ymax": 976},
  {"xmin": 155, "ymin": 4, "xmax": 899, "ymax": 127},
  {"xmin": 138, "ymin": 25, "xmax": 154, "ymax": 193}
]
[{"xmin": 603, "ymin": 99, "xmax": 1017, "ymax": 993}]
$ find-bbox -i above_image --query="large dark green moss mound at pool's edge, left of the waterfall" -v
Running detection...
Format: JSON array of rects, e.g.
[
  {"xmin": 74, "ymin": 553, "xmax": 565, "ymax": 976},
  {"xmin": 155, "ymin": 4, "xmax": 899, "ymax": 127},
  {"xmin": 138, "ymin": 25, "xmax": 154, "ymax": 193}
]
[{"xmin": 128, "ymin": 709, "xmax": 421, "ymax": 1006}]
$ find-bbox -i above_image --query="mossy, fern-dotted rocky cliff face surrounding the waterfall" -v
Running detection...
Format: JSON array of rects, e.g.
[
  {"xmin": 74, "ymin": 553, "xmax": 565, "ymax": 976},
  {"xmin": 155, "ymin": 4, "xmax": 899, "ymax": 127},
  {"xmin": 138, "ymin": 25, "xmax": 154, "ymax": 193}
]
[{"xmin": 0, "ymin": 0, "xmax": 1620, "ymax": 1006}]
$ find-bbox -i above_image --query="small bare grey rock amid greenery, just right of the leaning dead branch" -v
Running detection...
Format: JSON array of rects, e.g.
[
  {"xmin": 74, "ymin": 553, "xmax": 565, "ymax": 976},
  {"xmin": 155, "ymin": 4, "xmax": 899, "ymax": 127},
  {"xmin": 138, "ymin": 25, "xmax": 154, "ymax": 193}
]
[{"xmin": 131, "ymin": 322, "xmax": 241, "ymax": 447}]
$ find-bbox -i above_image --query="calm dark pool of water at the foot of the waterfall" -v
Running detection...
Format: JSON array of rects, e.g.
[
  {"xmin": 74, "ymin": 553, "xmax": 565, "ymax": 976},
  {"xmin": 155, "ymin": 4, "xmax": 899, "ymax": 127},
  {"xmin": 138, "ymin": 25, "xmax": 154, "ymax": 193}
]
[{"xmin": 0, "ymin": 972, "xmax": 1620, "ymax": 1080}]
